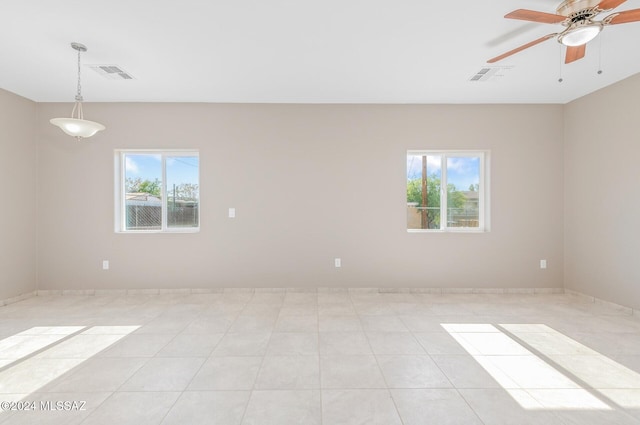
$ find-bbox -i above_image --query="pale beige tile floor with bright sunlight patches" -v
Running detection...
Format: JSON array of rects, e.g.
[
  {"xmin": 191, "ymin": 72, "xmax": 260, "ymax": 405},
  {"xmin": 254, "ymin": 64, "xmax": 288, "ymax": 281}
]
[{"xmin": 0, "ymin": 291, "xmax": 640, "ymax": 425}]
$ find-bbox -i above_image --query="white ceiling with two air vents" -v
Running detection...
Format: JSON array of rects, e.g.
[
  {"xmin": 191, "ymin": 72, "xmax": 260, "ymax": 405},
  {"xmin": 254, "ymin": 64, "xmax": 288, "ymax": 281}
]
[{"xmin": 0, "ymin": 0, "xmax": 640, "ymax": 103}]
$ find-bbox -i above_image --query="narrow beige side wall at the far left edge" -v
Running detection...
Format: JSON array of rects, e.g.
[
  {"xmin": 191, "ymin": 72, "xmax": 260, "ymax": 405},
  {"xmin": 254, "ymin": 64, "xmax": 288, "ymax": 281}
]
[{"xmin": 0, "ymin": 89, "xmax": 36, "ymax": 300}]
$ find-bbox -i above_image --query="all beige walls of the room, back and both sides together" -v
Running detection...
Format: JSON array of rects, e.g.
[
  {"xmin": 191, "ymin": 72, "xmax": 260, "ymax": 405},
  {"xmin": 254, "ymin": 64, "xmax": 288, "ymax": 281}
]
[{"xmin": 0, "ymin": 75, "xmax": 640, "ymax": 302}]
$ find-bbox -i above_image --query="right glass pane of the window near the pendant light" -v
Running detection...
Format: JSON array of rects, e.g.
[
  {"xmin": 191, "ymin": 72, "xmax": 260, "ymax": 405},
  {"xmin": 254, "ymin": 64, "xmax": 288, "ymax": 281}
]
[{"xmin": 166, "ymin": 156, "xmax": 200, "ymax": 227}]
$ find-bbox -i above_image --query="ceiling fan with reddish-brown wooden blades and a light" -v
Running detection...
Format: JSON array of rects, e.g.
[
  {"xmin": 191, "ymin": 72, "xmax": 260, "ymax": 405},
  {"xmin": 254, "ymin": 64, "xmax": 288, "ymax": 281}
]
[{"xmin": 487, "ymin": 0, "xmax": 640, "ymax": 63}]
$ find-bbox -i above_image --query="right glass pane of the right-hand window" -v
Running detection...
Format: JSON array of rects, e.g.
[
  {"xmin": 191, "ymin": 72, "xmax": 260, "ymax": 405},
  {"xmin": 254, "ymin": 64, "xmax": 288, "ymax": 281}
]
[{"xmin": 447, "ymin": 156, "xmax": 480, "ymax": 227}]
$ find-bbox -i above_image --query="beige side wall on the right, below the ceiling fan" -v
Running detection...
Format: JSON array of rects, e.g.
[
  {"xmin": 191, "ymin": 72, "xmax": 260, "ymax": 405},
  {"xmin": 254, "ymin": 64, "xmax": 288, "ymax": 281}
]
[{"xmin": 565, "ymin": 74, "xmax": 640, "ymax": 308}]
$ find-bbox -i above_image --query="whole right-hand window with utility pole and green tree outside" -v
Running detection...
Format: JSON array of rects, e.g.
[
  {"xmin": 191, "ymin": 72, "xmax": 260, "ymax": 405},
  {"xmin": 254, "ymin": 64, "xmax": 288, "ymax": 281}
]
[{"xmin": 407, "ymin": 151, "xmax": 489, "ymax": 231}]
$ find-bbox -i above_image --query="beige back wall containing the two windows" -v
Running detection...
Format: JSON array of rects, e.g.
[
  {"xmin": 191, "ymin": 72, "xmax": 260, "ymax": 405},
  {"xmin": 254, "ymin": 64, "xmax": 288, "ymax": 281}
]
[{"xmin": 37, "ymin": 103, "xmax": 564, "ymax": 289}]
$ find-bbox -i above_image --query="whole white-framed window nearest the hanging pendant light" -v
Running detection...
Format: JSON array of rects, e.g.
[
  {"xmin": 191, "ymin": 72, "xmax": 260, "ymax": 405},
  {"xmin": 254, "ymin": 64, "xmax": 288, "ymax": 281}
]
[{"xmin": 115, "ymin": 150, "xmax": 200, "ymax": 232}]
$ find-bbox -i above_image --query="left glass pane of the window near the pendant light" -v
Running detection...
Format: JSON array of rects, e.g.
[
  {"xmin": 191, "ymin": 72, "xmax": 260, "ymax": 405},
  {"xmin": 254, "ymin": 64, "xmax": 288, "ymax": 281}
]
[{"xmin": 124, "ymin": 154, "xmax": 162, "ymax": 230}]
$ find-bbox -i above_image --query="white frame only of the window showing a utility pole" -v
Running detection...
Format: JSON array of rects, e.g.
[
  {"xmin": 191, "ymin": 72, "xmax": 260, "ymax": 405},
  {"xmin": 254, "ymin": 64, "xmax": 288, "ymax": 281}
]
[{"xmin": 405, "ymin": 150, "xmax": 491, "ymax": 233}]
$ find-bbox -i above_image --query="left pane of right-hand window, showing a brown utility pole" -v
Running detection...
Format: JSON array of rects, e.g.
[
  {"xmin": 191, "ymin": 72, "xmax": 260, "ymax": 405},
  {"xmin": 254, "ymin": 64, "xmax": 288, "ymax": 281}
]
[{"xmin": 407, "ymin": 155, "xmax": 442, "ymax": 229}]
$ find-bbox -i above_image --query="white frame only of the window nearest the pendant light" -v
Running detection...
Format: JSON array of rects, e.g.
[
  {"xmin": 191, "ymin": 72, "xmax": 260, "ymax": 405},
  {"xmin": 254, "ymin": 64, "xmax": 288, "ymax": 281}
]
[{"xmin": 114, "ymin": 149, "xmax": 201, "ymax": 234}]
